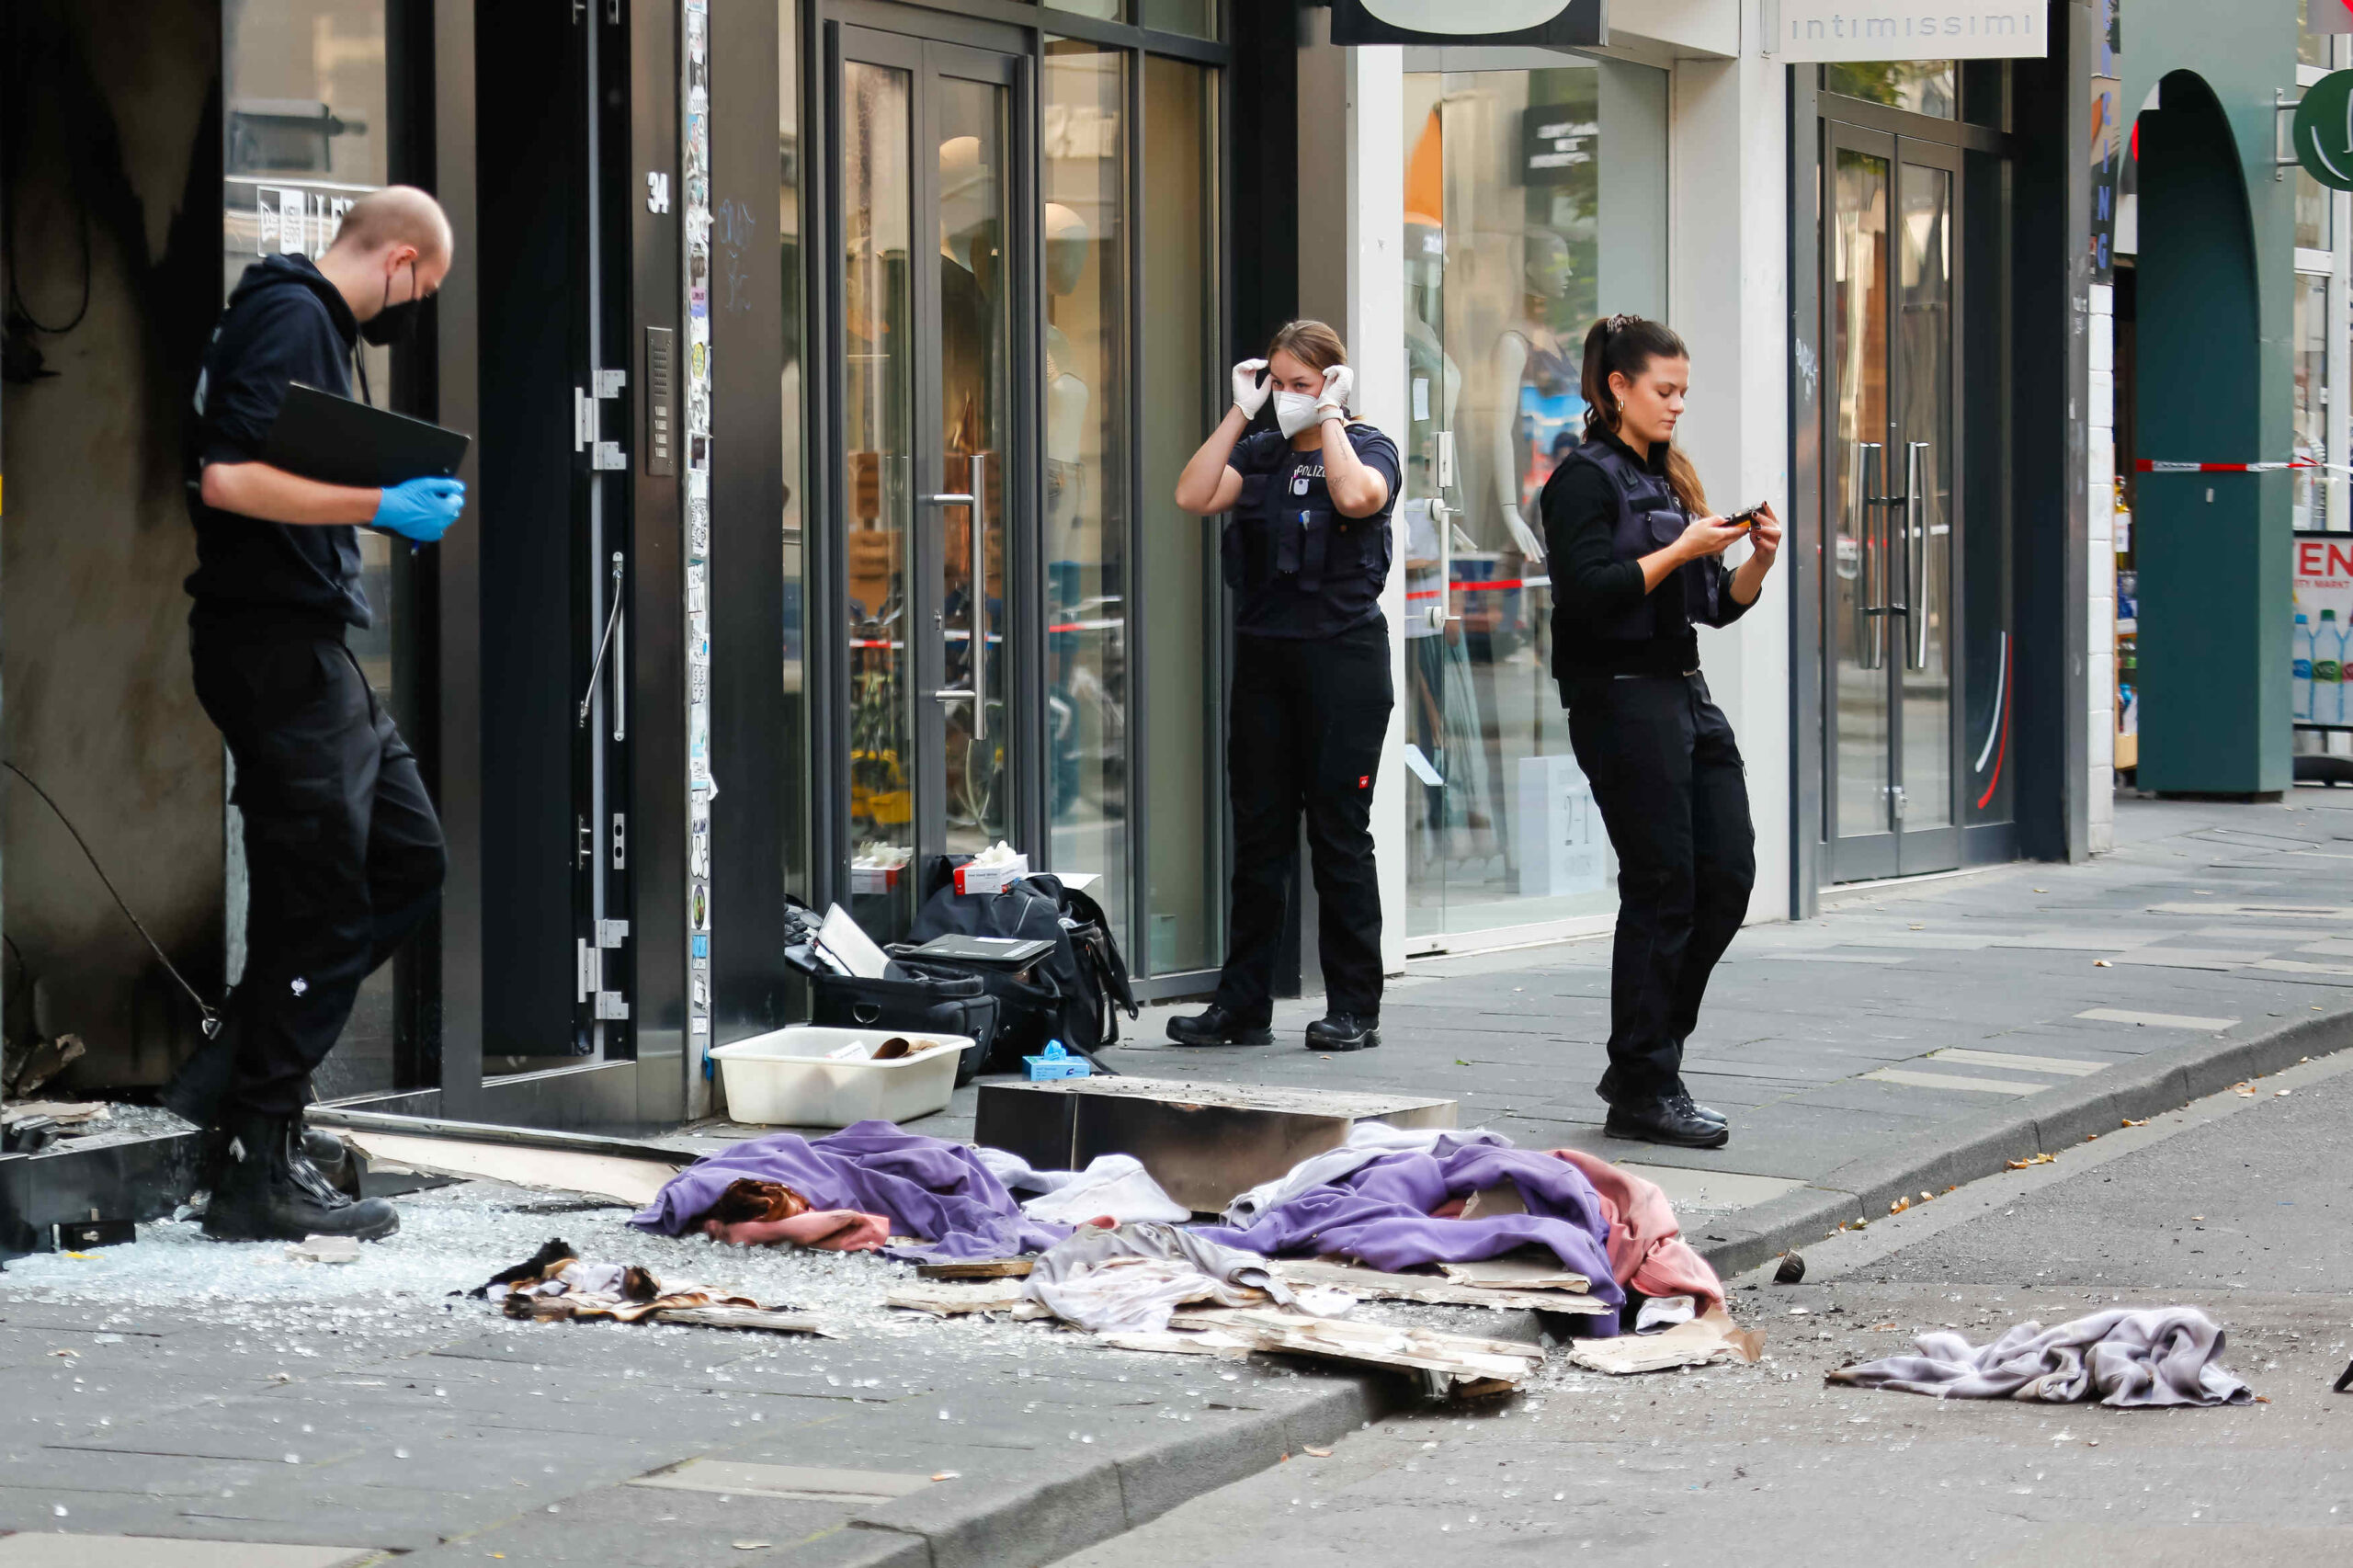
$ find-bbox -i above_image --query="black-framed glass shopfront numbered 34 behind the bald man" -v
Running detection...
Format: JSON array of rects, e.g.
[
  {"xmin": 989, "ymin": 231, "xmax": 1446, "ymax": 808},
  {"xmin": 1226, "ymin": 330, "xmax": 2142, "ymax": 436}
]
[{"xmin": 183, "ymin": 0, "xmax": 1233, "ymax": 1125}]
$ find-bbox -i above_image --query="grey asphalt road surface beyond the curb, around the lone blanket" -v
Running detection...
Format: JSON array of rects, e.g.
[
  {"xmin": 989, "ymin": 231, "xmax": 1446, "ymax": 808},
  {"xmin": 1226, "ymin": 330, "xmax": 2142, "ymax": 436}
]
[{"xmin": 1062, "ymin": 1021, "xmax": 2353, "ymax": 1568}]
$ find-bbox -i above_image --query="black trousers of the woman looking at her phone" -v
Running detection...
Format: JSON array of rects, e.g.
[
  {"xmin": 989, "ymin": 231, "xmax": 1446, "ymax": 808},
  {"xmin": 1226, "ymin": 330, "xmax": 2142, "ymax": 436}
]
[{"xmin": 1563, "ymin": 671, "xmax": 1757, "ymax": 1104}]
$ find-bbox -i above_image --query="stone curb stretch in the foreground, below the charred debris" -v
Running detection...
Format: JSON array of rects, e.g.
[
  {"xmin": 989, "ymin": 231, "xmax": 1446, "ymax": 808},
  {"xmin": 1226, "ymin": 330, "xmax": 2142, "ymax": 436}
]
[{"xmin": 828, "ymin": 1372, "xmax": 1409, "ymax": 1568}]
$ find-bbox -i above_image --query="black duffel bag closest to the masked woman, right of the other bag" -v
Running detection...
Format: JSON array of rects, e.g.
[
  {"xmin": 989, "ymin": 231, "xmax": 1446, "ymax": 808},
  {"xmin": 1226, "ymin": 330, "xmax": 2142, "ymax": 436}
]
[{"xmin": 892, "ymin": 862, "xmax": 1136, "ymax": 1074}]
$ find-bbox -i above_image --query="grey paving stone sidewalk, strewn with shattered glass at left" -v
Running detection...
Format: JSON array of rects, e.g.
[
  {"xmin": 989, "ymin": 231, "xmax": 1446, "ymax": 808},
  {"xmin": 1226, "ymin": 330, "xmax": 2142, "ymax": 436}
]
[{"xmin": 0, "ymin": 791, "xmax": 2353, "ymax": 1568}]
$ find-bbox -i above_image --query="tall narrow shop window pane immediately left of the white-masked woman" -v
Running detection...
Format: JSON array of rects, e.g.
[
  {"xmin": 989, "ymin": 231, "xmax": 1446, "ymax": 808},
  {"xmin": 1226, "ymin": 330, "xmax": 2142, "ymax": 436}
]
[{"xmin": 1139, "ymin": 54, "xmax": 1226, "ymax": 974}]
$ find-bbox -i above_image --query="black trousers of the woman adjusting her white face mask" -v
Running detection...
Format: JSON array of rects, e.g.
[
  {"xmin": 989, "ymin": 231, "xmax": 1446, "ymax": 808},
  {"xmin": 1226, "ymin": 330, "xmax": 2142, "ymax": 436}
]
[{"xmin": 1217, "ymin": 621, "xmax": 1395, "ymax": 1024}]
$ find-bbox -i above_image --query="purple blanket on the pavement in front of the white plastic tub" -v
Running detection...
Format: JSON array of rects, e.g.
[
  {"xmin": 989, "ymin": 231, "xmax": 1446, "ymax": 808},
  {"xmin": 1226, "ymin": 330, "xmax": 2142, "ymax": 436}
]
[{"xmin": 631, "ymin": 1120, "xmax": 1068, "ymax": 1274}]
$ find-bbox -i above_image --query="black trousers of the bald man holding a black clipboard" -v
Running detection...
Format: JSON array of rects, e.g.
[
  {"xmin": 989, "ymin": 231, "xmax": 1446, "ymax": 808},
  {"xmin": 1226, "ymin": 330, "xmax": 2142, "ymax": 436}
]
[{"xmin": 188, "ymin": 617, "xmax": 447, "ymax": 1116}]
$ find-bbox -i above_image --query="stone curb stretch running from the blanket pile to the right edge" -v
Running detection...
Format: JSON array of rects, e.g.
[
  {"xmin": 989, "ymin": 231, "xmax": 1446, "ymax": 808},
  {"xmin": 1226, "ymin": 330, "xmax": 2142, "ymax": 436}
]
[{"xmin": 1692, "ymin": 1012, "xmax": 2353, "ymax": 1278}]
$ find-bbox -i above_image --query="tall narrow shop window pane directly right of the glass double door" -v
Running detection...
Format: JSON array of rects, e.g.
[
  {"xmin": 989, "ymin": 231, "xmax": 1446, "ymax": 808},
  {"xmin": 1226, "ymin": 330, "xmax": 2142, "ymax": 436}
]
[{"xmin": 1040, "ymin": 38, "xmax": 1134, "ymax": 947}]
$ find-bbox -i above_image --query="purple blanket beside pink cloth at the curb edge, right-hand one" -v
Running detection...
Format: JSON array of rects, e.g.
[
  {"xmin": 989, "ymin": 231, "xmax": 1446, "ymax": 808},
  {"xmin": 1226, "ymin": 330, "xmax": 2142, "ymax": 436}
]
[{"xmin": 1200, "ymin": 1144, "xmax": 1626, "ymax": 1333}]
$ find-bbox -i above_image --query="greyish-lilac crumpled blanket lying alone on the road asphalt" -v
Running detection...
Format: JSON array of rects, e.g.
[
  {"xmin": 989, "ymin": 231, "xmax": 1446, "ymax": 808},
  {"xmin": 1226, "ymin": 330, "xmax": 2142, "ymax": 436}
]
[{"xmin": 1828, "ymin": 1307, "xmax": 2254, "ymax": 1408}]
